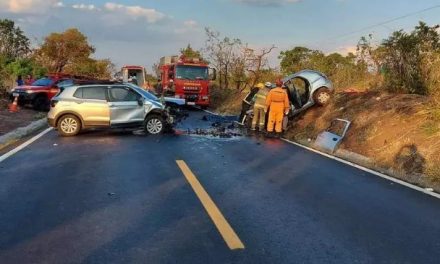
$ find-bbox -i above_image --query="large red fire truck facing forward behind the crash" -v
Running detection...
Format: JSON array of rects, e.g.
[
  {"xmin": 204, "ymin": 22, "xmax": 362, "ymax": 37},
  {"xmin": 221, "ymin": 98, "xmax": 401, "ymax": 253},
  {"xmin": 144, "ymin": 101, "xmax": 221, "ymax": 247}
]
[{"xmin": 157, "ymin": 56, "xmax": 216, "ymax": 108}]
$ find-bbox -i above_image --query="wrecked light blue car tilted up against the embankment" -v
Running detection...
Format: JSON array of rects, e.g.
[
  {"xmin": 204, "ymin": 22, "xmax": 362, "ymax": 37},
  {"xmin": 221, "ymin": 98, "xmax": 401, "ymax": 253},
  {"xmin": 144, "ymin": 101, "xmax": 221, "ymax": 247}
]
[{"xmin": 240, "ymin": 70, "xmax": 334, "ymax": 125}]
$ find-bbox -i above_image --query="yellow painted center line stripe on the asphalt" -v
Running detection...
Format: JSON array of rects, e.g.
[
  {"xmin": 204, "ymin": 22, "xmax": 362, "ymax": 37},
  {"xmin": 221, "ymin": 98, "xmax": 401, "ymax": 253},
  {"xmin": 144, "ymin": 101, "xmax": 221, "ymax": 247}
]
[{"xmin": 176, "ymin": 160, "xmax": 244, "ymax": 250}]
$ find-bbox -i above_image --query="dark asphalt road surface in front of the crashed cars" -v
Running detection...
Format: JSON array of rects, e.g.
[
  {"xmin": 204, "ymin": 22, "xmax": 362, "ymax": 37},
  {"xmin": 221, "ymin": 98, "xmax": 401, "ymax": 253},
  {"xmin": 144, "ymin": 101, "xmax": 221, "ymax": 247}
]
[{"xmin": 0, "ymin": 112, "xmax": 440, "ymax": 264}]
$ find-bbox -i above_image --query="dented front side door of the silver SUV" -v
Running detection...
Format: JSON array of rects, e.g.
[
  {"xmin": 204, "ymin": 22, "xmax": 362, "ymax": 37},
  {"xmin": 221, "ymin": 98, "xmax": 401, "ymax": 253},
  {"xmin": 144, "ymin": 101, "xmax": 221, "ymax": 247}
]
[{"xmin": 108, "ymin": 86, "xmax": 145, "ymax": 125}]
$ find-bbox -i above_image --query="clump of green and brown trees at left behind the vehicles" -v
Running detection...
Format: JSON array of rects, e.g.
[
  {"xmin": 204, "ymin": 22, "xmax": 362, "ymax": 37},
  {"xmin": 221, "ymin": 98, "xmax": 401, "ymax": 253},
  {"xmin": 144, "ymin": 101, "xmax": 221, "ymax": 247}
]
[{"xmin": 0, "ymin": 19, "xmax": 114, "ymax": 93}]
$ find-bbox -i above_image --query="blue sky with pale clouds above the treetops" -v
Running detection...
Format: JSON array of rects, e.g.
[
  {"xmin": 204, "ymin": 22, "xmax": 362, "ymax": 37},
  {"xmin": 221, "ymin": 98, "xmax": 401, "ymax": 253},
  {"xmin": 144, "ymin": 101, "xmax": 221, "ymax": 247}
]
[{"xmin": 0, "ymin": 0, "xmax": 440, "ymax": 71}]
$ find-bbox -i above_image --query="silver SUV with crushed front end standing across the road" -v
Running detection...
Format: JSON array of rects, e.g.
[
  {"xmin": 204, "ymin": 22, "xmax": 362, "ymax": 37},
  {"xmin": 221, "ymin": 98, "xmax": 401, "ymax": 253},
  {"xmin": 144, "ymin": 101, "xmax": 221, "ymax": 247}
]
[{"xmin": 47, "ymin": 83, "xmax": 173, "ymax": 136}]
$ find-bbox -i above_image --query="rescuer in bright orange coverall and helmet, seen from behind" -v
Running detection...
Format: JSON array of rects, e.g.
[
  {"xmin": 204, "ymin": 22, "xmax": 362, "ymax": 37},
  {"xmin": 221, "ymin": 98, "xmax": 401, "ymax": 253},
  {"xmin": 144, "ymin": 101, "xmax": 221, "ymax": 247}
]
[{"xmin": 266, "ymin": 87, "xmax": 290, "ymax": 133}]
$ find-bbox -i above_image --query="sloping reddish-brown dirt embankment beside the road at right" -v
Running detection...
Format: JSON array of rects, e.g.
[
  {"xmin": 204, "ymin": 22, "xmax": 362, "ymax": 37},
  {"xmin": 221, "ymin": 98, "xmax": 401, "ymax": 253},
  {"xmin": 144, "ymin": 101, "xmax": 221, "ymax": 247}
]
[{"xmin": 286, "ymin": 92, "xmax": 440, "ymax": 190}]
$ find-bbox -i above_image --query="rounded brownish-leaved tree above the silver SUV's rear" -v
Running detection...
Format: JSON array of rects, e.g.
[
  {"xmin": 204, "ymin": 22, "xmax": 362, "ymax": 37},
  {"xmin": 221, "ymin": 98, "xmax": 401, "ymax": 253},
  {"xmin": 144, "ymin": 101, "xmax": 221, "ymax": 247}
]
[{"xmin": 37, "ymin": 28, "xmax": 95, "ymax": 72}]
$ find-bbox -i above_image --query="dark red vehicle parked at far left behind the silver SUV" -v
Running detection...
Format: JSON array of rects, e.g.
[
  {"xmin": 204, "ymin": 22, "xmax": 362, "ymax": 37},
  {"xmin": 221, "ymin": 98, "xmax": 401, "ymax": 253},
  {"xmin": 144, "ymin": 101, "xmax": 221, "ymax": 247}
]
[{"xmin": 10, "ymin": 74, "xmax": 73, "ymax": 111}]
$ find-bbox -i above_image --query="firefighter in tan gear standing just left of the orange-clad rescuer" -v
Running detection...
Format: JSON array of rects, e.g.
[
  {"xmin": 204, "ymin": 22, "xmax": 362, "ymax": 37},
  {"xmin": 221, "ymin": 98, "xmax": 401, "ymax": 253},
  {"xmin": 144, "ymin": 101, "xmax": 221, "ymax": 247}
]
[{"xmin": 251, "ymin": 82, "xmax": 272, "ymax": 132}]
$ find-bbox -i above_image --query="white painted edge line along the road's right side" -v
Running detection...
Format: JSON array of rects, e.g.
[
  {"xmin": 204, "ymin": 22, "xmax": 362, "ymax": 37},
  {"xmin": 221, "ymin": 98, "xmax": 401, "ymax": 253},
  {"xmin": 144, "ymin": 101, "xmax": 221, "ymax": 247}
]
[{"xmin": 281, "ymin": 138, "xmax": 440, "ymax": 199}]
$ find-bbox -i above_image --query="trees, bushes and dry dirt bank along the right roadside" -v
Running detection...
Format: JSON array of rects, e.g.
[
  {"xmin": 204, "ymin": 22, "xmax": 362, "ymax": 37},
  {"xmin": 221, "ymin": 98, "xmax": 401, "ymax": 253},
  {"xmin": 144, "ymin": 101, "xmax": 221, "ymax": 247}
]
[{"xmin": 205, "ymin": 22, "xmax": 440, "ymax": 191}]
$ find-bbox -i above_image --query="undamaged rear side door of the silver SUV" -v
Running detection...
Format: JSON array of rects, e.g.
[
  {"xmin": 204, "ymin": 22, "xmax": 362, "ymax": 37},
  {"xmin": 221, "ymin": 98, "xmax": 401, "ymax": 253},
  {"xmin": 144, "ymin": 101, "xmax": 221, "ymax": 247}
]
[{"xmin": 73, "ymin": 86, "xmax": 110, "ymax": 126}]
